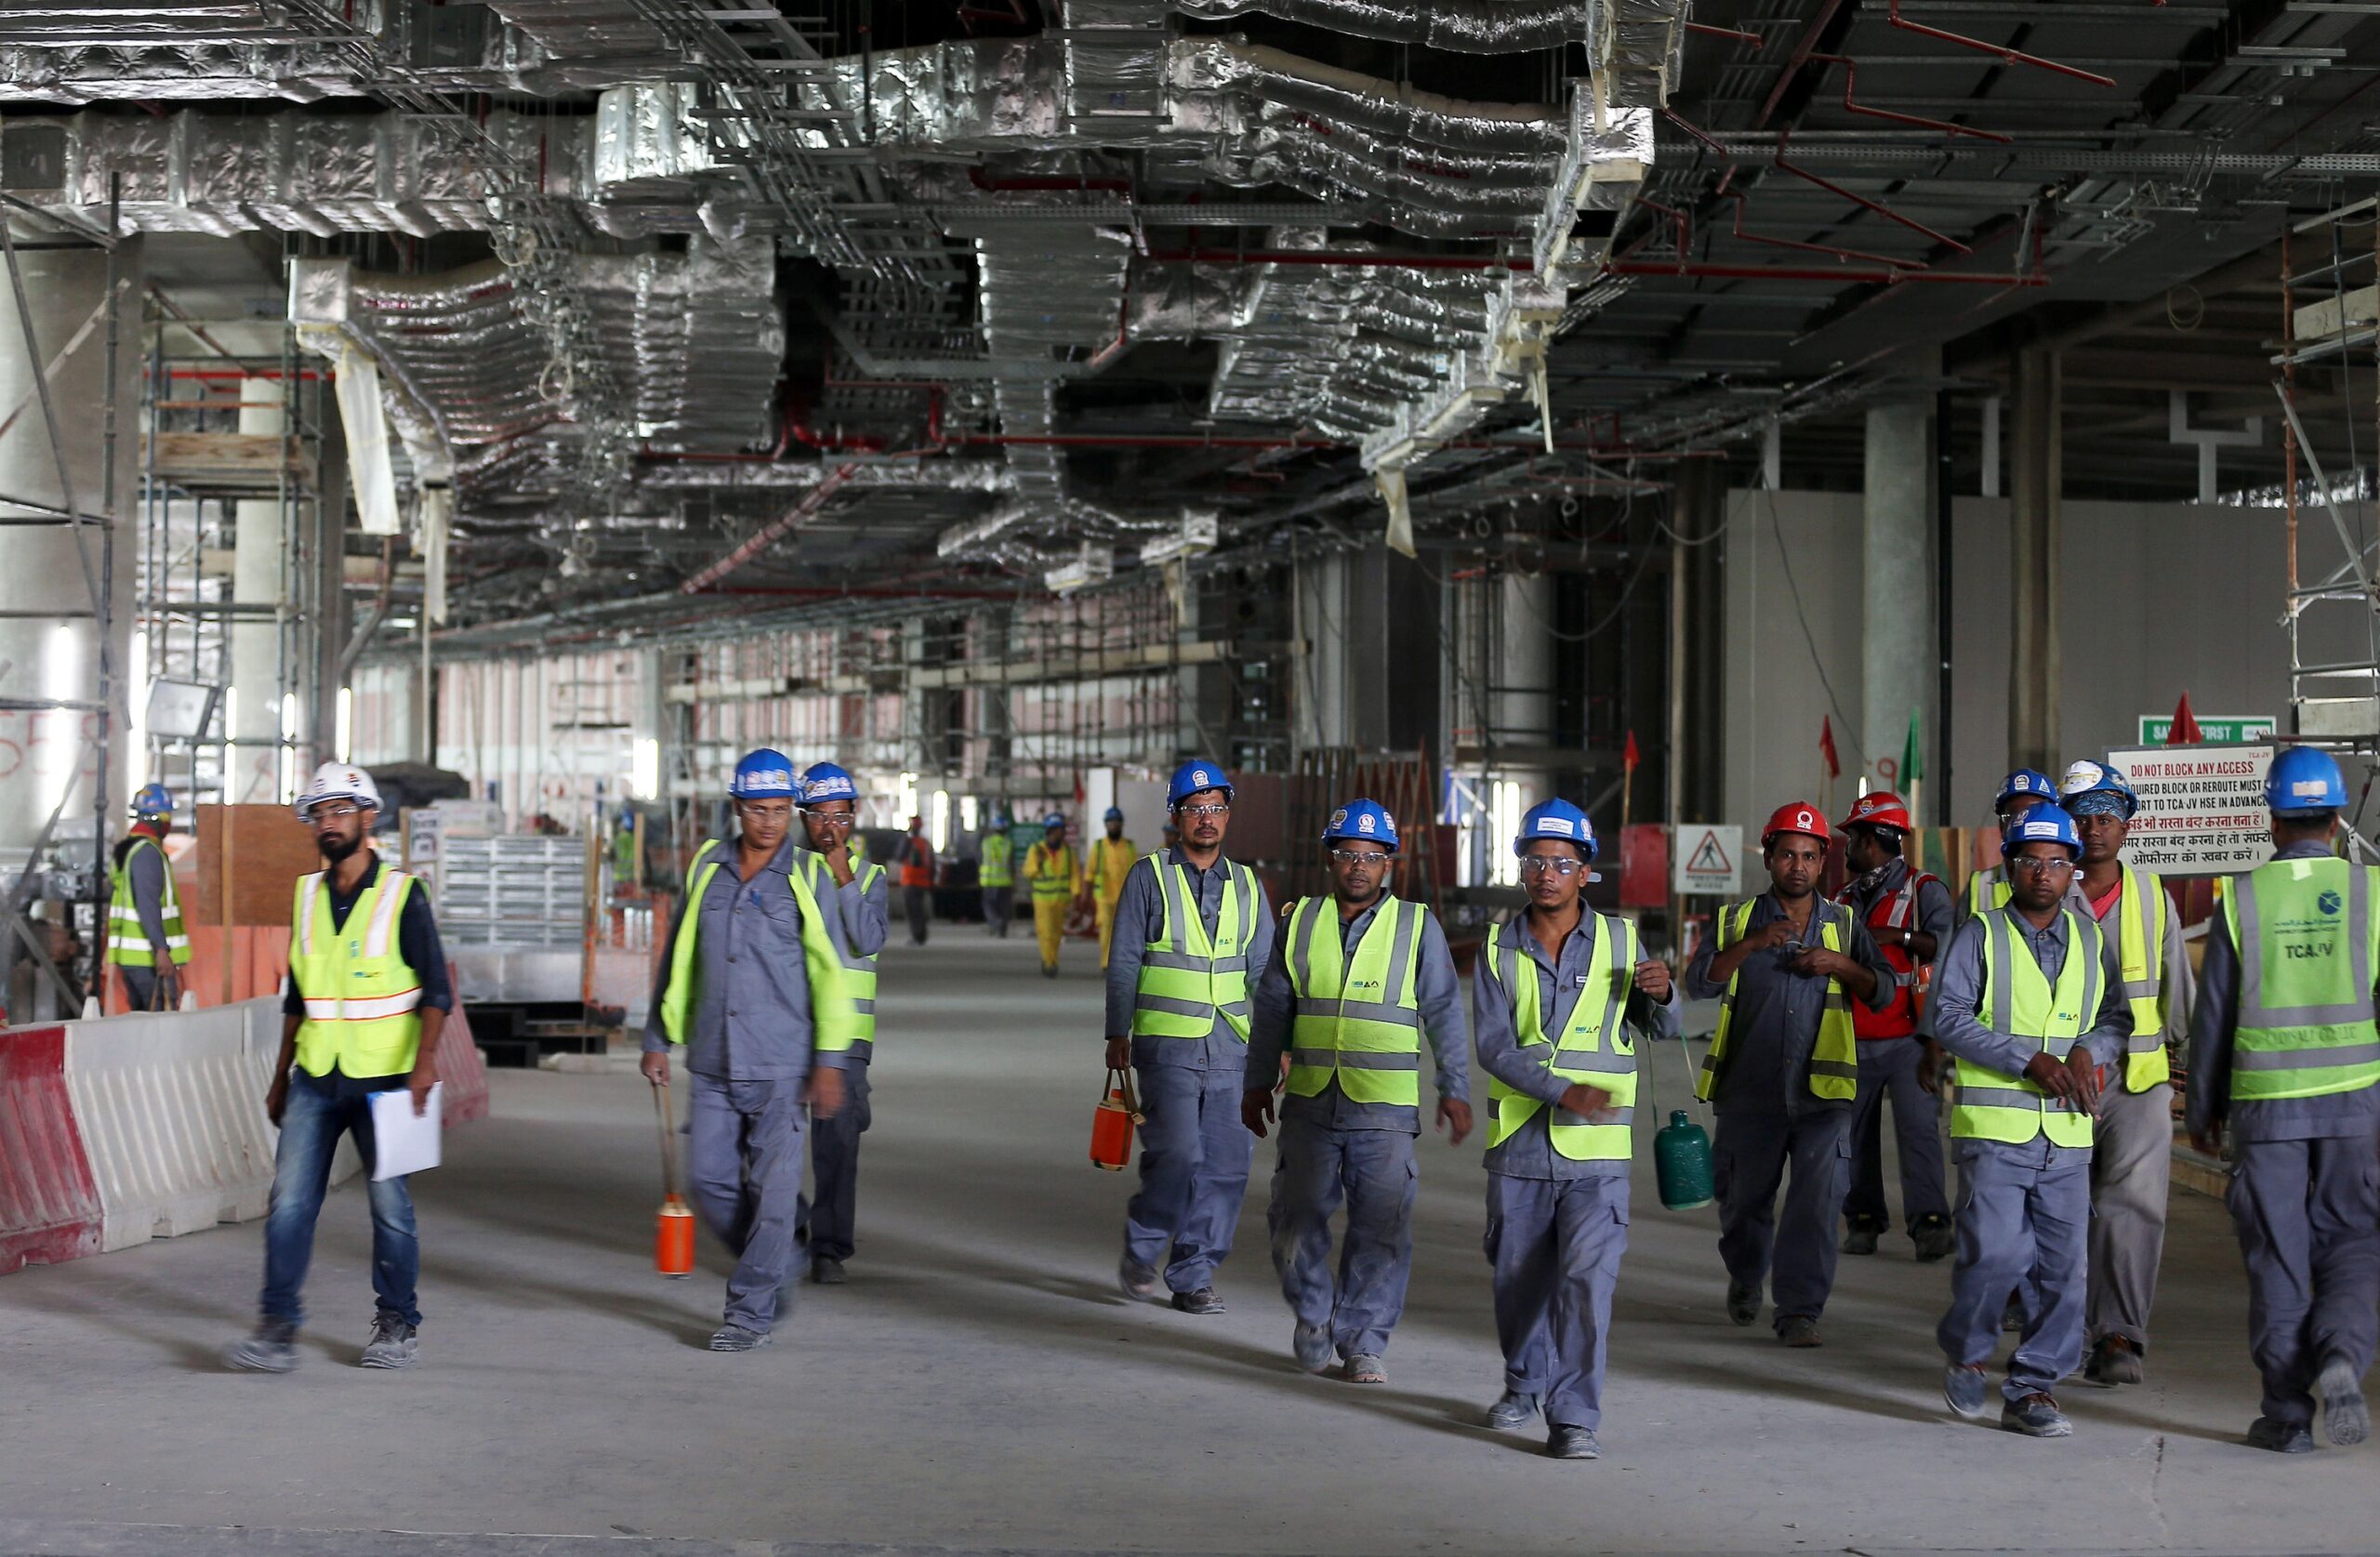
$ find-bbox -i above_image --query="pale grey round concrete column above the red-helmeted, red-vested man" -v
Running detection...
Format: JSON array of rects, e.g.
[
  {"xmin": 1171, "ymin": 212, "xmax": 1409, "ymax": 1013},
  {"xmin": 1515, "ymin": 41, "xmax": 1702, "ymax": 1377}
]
[{"xmin": 1858, "ymin": 398, "xmax": 1939, "ymax": 810}]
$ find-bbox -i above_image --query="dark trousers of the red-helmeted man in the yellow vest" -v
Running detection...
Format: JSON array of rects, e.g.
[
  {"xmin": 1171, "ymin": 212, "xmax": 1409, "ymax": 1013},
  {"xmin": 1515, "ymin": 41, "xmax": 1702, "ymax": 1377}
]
[{"xmin": 1712, "ymin": 1110, "xmax": 1852, "ymax": 1326}]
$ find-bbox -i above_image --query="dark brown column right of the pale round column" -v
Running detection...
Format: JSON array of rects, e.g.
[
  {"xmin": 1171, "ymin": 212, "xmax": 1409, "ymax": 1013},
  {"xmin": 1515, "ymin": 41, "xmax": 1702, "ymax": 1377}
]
[{"xmin": 2009, "ymin": 348, "xmax": 2064, "ymax": 773}]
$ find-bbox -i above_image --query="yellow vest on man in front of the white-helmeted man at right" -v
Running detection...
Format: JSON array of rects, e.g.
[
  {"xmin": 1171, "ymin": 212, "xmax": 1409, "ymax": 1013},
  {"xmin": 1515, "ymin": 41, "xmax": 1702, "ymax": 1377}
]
[{"xmin": 1950, "ymin": 907, "xmax": 2107, "ymax": 1145}]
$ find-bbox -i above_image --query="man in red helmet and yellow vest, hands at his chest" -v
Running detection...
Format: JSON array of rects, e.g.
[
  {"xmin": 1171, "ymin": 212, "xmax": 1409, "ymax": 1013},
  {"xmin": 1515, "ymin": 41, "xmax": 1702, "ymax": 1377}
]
[{"xmin": 1685, "ymin": 802, "xmax": 1897, "ymax": 1348}]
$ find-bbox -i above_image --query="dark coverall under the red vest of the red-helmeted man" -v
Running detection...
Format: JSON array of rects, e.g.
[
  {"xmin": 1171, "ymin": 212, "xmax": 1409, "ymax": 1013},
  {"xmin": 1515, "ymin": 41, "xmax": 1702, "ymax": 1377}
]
[{"xmin": 1842, "ymin": 860, "xmax": 1954, "ymax": 1234}]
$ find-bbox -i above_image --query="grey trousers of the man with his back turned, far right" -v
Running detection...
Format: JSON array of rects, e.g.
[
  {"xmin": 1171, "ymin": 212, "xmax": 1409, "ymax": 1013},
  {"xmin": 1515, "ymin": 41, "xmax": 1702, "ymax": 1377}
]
[{"xmin": 2226, "ymin": 1133, "xmax": 2380, "ymax": 1421}]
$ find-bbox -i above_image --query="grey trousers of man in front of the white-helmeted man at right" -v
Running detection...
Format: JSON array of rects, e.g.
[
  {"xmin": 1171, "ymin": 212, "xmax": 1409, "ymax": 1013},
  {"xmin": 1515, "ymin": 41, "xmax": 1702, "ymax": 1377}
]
[{"xmin": 1935, "ymin": 1136, "xmax": 2090, "ymax": 1400}]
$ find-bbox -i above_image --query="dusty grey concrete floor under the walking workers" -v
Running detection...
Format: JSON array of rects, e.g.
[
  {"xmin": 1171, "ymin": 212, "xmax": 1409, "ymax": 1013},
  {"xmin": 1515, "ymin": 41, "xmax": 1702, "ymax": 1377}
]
[{"xmin": 14, "ymin": 926, "xmax": 2380, "ymax": 1554}]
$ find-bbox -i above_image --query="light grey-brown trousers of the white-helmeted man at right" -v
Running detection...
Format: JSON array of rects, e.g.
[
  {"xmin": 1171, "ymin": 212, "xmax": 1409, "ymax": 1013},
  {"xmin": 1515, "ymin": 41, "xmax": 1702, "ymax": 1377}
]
[{"xmin": 2087, "ymin": 1069, "xmax": 2173, "ymax": 1350}]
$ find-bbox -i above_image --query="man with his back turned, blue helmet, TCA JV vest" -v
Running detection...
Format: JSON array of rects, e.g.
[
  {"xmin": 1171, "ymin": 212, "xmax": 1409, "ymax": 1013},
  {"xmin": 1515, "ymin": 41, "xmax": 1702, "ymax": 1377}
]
[{"xmin": 2188, "ymin": 746, "xmax": 2380, "ymax": 1455}]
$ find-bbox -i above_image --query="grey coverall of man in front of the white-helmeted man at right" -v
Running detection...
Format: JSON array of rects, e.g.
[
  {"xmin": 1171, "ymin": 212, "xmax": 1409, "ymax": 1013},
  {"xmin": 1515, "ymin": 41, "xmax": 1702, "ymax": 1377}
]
[{"xmin": 1933, "ymin": 904, "xmax": 2133, "ymax": 1400}]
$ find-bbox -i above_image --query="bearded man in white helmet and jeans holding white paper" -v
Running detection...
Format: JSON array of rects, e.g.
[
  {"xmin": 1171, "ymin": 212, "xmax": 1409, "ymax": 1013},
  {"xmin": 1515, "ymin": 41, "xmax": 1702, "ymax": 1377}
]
[{"xmin": 226, "ymin": 762, "xmax": 455, "ymax": 1374}]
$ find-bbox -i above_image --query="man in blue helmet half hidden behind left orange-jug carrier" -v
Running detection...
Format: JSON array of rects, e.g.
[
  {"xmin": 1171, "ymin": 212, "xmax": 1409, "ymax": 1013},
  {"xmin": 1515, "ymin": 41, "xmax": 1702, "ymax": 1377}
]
[{"xmin": 798, "ymin": 762, "xmax": 890, "ymax": 1286}]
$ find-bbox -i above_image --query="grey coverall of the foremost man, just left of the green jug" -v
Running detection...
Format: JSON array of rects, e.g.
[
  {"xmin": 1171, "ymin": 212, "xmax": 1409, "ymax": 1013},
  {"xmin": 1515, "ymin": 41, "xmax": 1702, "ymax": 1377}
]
[{"xmin": 1471, "ymin": 912, "xmax": 1678, "ymax": 1429}]
